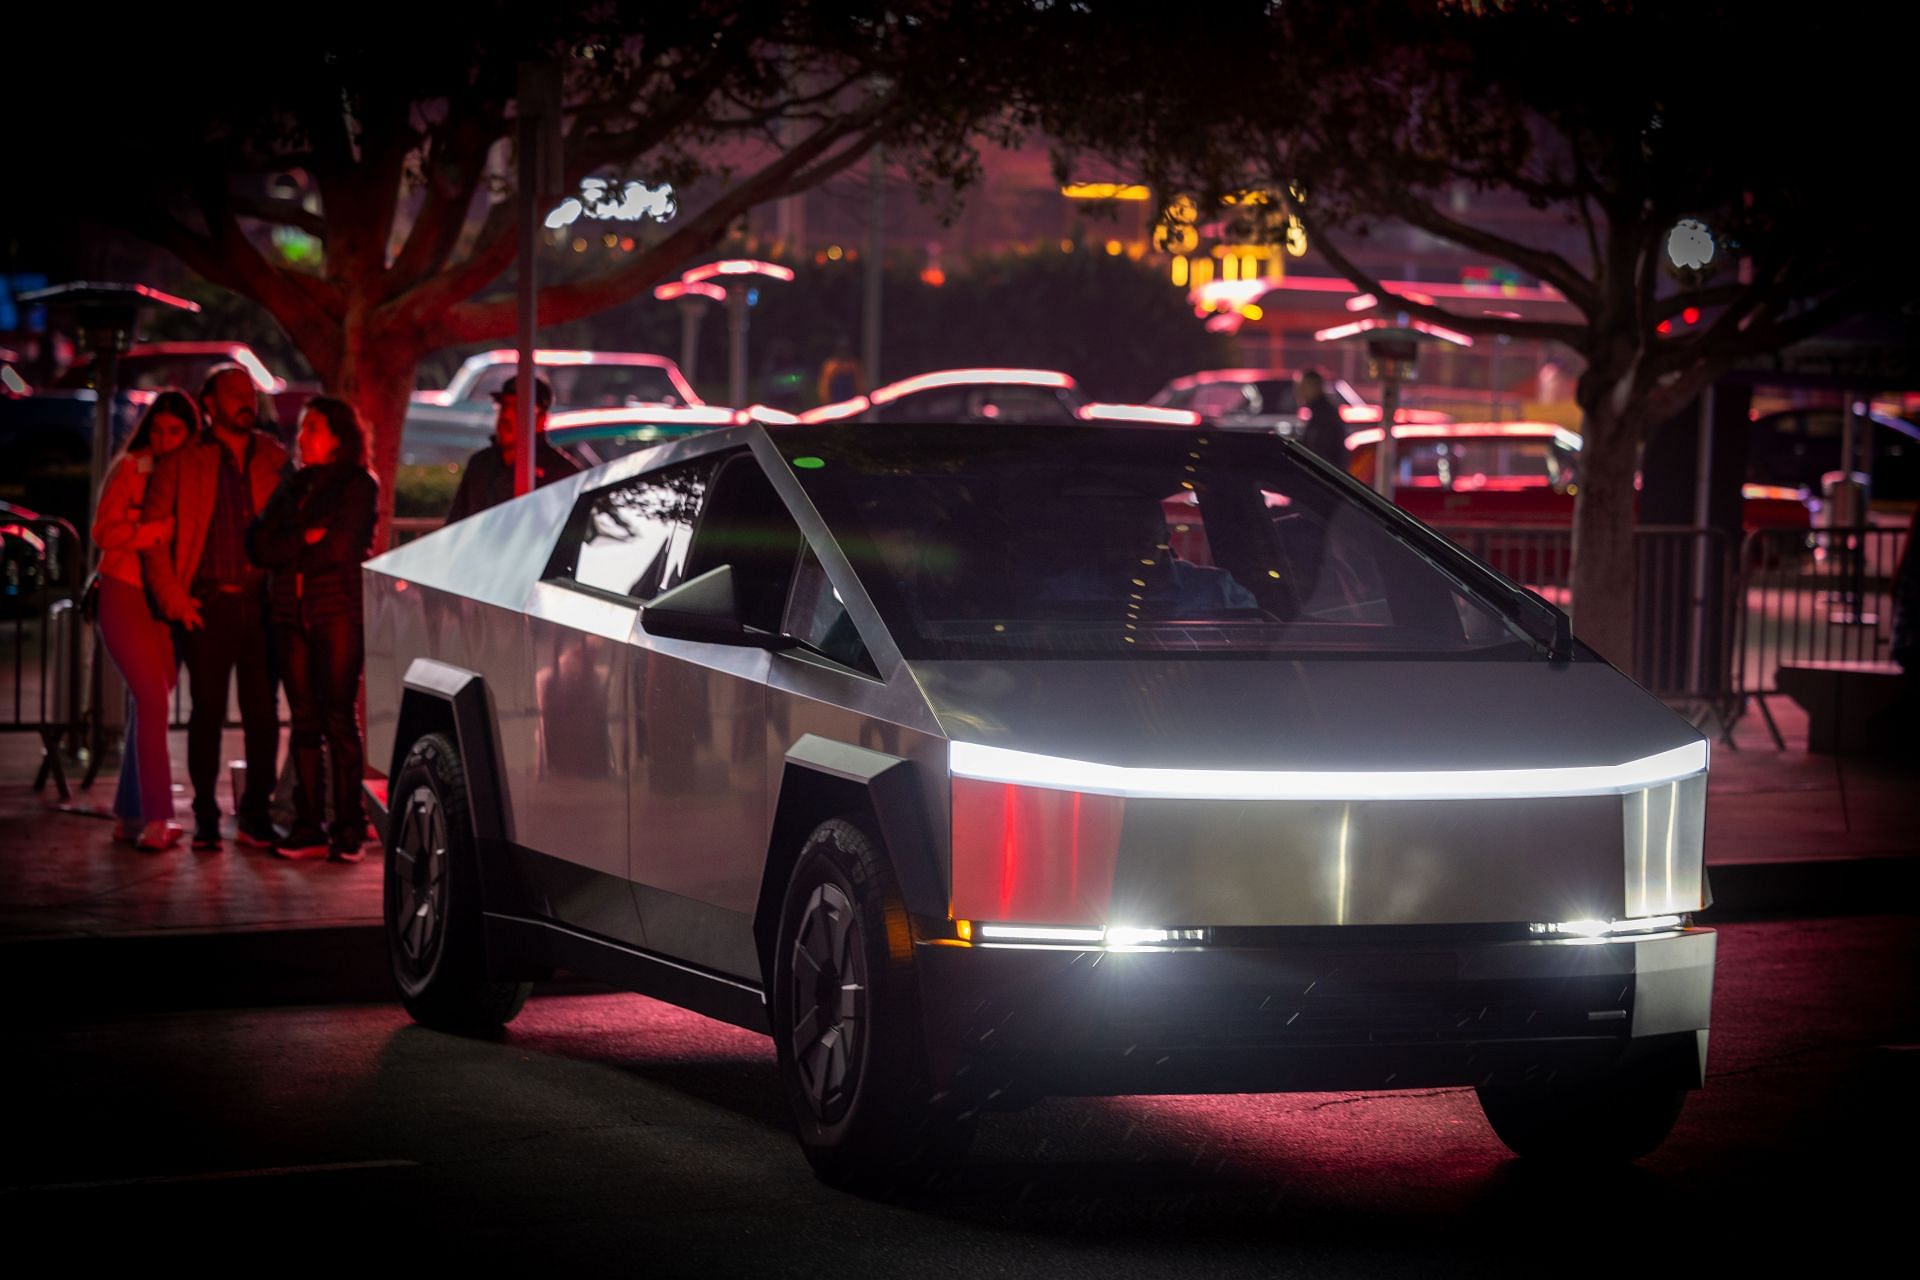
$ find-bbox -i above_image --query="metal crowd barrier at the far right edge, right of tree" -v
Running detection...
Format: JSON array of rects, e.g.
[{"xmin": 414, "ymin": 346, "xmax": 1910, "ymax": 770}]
[{"xmin": 1734, "ymin": 526, "xmax": 1907, "ymax": 748}]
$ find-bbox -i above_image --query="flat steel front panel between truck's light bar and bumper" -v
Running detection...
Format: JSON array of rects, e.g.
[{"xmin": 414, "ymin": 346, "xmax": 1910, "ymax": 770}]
[{"xmin": 952, "ymin": 794, "xmax": 1622, "ymax": 927}]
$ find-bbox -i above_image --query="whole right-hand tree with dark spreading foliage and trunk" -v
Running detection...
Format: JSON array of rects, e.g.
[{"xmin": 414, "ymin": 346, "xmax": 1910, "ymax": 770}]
[{"xmin": 1043, "ymin": 0, "xmax": 1916, "ymax": 654}]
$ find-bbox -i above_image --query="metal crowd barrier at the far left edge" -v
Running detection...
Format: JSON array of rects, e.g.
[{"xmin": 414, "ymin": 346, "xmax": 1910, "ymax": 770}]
[{"xmin": 0, "ymin": 503, "xmax": 86, "ymax": 800}]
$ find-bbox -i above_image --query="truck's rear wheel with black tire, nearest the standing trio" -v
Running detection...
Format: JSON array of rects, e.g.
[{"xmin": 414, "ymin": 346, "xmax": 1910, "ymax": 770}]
[{"xmin": 384, "ymin": 733, "xmax": 532, "ymax": 1034}]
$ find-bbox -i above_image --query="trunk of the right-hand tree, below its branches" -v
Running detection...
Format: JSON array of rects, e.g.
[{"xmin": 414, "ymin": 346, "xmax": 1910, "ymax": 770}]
[{"xmin": 1572, "ymin": 395, "xmax": 1640, "ymax": 672}]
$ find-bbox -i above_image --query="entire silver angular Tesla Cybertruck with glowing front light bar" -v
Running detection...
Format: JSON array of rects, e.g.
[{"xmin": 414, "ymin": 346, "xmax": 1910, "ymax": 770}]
[{"xmin": 365, "ymin": 424, "xmax": 1715, "ymax": 1186}]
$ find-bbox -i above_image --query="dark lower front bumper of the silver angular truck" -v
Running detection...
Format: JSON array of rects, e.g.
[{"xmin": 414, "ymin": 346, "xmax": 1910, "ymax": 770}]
[{"xmin": 916, "ymin": 927, "xmax": 1715, "ymax": 1096}]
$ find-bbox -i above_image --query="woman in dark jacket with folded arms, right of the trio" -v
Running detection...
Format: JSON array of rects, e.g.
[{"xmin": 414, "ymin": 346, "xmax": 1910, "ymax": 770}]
[{"xmin": 248, "ymin": 395, "xmax": 380, "ymax": 862}]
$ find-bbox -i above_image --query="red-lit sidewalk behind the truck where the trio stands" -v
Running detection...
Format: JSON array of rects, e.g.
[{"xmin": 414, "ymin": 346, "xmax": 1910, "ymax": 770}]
[{"xmin": 0, "ymin": 699, "xmax": 1920, "ymax": 1007}]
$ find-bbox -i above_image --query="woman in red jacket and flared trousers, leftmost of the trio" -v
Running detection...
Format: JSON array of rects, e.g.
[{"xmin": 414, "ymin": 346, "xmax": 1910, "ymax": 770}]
[{"xmin": 94, "ymin": 388, "xmax": 200, "ymax": 852}]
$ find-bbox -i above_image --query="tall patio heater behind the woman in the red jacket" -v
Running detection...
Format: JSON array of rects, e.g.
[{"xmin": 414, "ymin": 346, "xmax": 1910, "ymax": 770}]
[{"xmin": 19, "ymin": 280, "xmax": 200, "ymax": 818}]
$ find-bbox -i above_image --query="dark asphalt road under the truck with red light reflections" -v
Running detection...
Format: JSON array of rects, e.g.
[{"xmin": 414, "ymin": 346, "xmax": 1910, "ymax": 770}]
[{"xmin": 0, "ymin": 913, "xmax": 1920, "ymax": 1280}]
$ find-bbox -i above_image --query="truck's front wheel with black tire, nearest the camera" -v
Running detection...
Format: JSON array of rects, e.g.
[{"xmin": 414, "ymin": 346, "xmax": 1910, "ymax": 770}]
[{"xmin": 772, "ymin": 818, "xmax": 973, "ymax": 1196}]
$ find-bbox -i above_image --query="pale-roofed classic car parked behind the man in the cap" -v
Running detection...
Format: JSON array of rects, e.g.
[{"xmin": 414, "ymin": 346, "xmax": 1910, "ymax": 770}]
[{"xmin": 399, "ymin": 347, "xmax": 701, "ymax": 466}]
